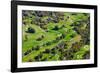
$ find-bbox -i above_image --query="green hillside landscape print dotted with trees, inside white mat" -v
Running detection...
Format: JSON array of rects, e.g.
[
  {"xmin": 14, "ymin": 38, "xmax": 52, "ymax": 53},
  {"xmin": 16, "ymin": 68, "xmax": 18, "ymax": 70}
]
[{"xmin": 22, "ymin": 10, "xmax": 90, "ymax": 62}]
